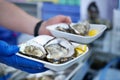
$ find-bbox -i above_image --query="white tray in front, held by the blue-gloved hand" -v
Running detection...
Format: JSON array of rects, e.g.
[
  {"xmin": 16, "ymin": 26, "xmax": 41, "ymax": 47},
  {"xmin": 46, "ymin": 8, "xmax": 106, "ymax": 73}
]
[{"xmin": 17, "ymin": 35, "xmax": 89, "ymax": 71}]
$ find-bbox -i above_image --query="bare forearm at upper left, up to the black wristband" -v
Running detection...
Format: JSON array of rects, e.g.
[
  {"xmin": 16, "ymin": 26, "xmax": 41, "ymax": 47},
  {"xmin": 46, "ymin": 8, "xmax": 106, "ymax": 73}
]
[{"xmin": 0, "ymin": 0, "xmax": 39, "ymax": 34}]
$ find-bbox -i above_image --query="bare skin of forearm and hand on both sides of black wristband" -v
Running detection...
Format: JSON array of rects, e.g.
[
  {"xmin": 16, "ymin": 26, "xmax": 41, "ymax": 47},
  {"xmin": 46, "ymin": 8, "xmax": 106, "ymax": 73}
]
[{"xmin": 0, "ymin": 0, "xmax": 71, "ymax": 35}]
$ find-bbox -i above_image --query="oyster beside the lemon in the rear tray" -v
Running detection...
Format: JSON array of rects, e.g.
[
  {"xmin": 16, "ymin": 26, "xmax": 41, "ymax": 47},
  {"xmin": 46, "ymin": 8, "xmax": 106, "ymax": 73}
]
[{"xmin": 70, "ymin": 22, "xmax": 90, "ymax": 36}]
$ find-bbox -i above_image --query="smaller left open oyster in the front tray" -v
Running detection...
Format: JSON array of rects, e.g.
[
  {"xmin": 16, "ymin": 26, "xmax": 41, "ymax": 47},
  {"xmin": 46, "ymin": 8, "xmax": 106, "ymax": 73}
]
[{"xmin": 22, "ymin": 42, "xmax": 46, "ymax": 59}]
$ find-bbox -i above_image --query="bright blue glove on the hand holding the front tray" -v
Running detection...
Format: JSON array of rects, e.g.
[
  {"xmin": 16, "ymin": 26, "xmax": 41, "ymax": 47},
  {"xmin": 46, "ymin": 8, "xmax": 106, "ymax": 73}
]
[{"xmin": 0, "ymin": 40, "xmax": 47, "ymax": 73}]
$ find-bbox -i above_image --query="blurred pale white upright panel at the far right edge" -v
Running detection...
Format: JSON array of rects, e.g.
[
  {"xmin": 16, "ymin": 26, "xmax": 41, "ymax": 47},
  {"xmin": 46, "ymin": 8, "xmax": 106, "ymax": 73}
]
[{"xmin": 111, "ymin": 10, "xmax": 120, "ymax": 55}]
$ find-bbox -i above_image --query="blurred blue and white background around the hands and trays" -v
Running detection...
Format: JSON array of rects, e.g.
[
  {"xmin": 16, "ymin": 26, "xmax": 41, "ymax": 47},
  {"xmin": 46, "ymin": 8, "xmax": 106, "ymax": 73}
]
[{"xmin": 0, "ymin": 0, "xmax": 120, "ymax": 80}]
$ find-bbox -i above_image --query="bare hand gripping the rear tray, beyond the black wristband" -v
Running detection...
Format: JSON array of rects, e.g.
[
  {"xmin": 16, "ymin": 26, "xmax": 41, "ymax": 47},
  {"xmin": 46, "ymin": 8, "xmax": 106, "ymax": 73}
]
[{"xmin": 39, "ymin": 15, "xmax": 71, "ymax": 35}]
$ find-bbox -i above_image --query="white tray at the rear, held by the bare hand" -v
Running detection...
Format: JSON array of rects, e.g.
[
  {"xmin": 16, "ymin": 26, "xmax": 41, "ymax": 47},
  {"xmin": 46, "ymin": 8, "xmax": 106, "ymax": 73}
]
[{"xmin": 47, "ymin": 23, "xmax": 107, "ymax": 44}]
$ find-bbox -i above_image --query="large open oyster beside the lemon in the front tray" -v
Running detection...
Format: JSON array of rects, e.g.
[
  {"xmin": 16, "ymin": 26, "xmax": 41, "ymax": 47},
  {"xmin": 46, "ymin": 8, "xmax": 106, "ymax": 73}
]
[{"xmin": 44, "ymin": 38, "xmax": 74, "ymax": 61}]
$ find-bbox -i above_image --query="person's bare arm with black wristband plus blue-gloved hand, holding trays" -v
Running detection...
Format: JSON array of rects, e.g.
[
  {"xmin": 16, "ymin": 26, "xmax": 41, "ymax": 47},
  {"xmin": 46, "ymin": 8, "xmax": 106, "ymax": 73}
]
[{"xmin": 0, "ymin": 0, "xmax": 71, "ymax": 73}]
